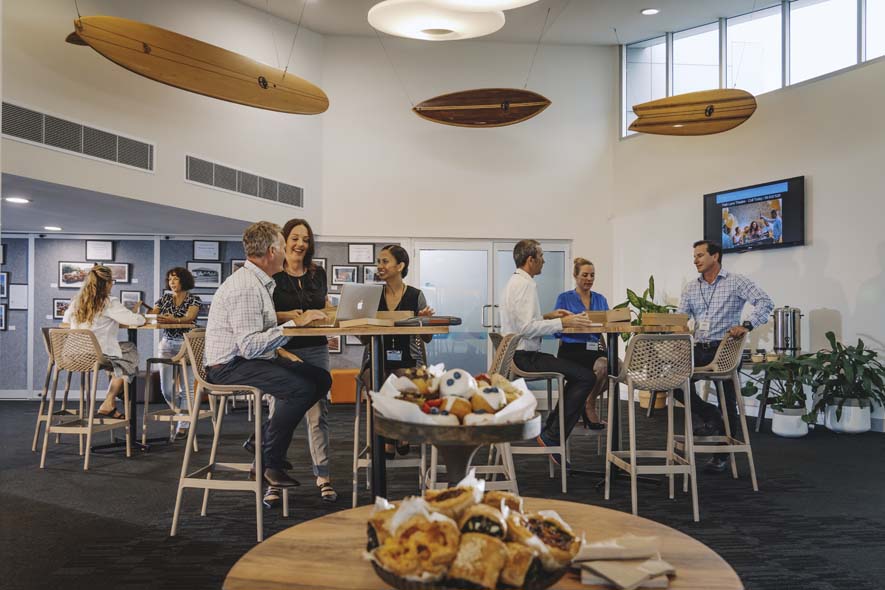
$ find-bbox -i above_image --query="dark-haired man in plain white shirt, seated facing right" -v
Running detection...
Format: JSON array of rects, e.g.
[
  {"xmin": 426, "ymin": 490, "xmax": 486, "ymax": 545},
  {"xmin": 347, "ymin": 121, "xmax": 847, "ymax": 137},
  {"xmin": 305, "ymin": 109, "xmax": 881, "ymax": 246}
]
[{"xmin": 501, "ymin": 240, "xmax": 596, "ymax": 463}]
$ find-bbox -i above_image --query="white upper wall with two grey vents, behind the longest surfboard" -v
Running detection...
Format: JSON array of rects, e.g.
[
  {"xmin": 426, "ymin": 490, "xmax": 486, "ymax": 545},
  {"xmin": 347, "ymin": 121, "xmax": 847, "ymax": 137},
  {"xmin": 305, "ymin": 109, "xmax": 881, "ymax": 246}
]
[{"xmin": 2, "ymin": 0, "xmax": 323, "ymax": 231}]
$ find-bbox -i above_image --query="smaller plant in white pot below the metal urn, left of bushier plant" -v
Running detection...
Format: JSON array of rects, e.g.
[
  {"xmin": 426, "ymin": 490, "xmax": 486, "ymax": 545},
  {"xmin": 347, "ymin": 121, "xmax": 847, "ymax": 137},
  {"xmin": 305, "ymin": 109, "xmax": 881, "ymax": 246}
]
[{"xmin": 741, "ymin": 354, "xmax": 815, "ymax": 438}]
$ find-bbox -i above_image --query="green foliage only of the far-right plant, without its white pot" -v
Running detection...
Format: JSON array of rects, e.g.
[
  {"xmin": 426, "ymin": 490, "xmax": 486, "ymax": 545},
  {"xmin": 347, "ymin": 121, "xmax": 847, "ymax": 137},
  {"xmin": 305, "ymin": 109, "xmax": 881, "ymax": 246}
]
[{"xmin": 805, "ymin": 332, "xmax": 885, "ymax": 422}]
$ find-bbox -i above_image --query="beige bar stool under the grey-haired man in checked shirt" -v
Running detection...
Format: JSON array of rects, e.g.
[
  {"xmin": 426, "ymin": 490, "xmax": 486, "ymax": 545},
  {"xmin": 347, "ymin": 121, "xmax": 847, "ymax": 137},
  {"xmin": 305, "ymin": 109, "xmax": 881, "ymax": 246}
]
[{"xmin": 169, "ymin": 330, "xmax": 289, "ymax": 543}]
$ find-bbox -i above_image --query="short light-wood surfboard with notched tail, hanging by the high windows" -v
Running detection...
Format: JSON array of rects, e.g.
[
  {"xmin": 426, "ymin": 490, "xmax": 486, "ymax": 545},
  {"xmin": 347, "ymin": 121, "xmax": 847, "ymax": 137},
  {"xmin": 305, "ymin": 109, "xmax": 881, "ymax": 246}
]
[{"xmin": 630, "ymin": 88, "xmax": 756, "ymax": 135}]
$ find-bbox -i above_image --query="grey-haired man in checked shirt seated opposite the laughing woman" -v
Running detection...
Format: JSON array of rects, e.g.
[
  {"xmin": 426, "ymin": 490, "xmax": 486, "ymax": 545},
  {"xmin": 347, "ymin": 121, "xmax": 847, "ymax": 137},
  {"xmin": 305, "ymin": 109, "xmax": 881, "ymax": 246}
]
[{"xmin": 205, "ymin": 221, "xmax": 332, "ymax": 487}]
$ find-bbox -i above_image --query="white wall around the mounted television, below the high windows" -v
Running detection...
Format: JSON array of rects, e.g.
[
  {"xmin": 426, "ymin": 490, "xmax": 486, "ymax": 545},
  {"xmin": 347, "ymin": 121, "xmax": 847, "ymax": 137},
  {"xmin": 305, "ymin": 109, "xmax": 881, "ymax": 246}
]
[{"xmin": 612, "ymin": 60, "xmax": 885, "ymax": 350}]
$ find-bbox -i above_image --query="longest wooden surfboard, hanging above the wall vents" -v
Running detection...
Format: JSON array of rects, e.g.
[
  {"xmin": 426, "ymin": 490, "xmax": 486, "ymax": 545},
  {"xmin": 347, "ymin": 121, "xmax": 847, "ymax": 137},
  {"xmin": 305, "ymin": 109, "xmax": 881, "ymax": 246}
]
[{"xmin": 66, "ymin": 16, "xmax": 329, "ymax": 115}]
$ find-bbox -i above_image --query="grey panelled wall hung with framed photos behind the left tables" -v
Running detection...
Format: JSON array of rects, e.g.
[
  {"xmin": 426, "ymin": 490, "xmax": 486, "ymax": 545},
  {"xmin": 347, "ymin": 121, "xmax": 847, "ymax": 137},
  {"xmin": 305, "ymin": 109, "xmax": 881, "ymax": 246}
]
[{"xmin": 0, "ymin": 237, "xmax": 400, "ymax": 391}]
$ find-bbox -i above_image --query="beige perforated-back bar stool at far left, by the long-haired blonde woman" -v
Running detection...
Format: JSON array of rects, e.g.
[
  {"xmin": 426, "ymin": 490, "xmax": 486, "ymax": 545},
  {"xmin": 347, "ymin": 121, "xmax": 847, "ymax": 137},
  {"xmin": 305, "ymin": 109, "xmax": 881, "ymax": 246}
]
[{"xmin": 40, "ymin": 328, "xmax": 132, "ymax": 471}]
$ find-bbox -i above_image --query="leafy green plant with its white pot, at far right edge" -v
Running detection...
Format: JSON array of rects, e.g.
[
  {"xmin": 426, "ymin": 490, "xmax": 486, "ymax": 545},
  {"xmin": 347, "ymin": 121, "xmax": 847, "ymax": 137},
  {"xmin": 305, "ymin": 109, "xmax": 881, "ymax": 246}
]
[{"xmin": 805, "ymin": 332, "xmax": 885, "ymax": 433}]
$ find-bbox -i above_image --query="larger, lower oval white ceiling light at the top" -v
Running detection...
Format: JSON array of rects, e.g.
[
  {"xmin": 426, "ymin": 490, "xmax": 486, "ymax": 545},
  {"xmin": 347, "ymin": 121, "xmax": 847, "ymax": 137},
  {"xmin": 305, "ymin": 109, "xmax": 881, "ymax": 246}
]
[{"xmin": 369, "ymin": 0, "xmax": 504, "ymax": 41}]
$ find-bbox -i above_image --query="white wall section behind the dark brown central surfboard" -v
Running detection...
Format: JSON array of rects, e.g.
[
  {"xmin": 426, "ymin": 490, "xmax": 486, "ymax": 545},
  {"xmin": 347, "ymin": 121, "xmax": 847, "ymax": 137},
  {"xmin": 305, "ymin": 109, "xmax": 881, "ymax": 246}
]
[{"xmin": 321, "ymin": 37, "xmax": 618, "ymax": 291}]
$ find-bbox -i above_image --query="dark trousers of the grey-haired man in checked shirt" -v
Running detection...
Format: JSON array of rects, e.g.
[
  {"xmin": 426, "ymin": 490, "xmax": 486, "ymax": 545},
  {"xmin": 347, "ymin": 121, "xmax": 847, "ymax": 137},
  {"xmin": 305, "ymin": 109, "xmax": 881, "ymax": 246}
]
[{"xmin": 206, "ymin": 357, "xmax": 332, "ymax": 469}]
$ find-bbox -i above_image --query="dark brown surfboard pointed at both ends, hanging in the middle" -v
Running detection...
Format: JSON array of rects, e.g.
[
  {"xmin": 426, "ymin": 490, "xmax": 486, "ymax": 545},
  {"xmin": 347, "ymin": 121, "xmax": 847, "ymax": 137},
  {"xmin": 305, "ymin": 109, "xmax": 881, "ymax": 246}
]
[{"xmin": 412, "ymin": 88, "xmax": 550, "ymax": 127}]
